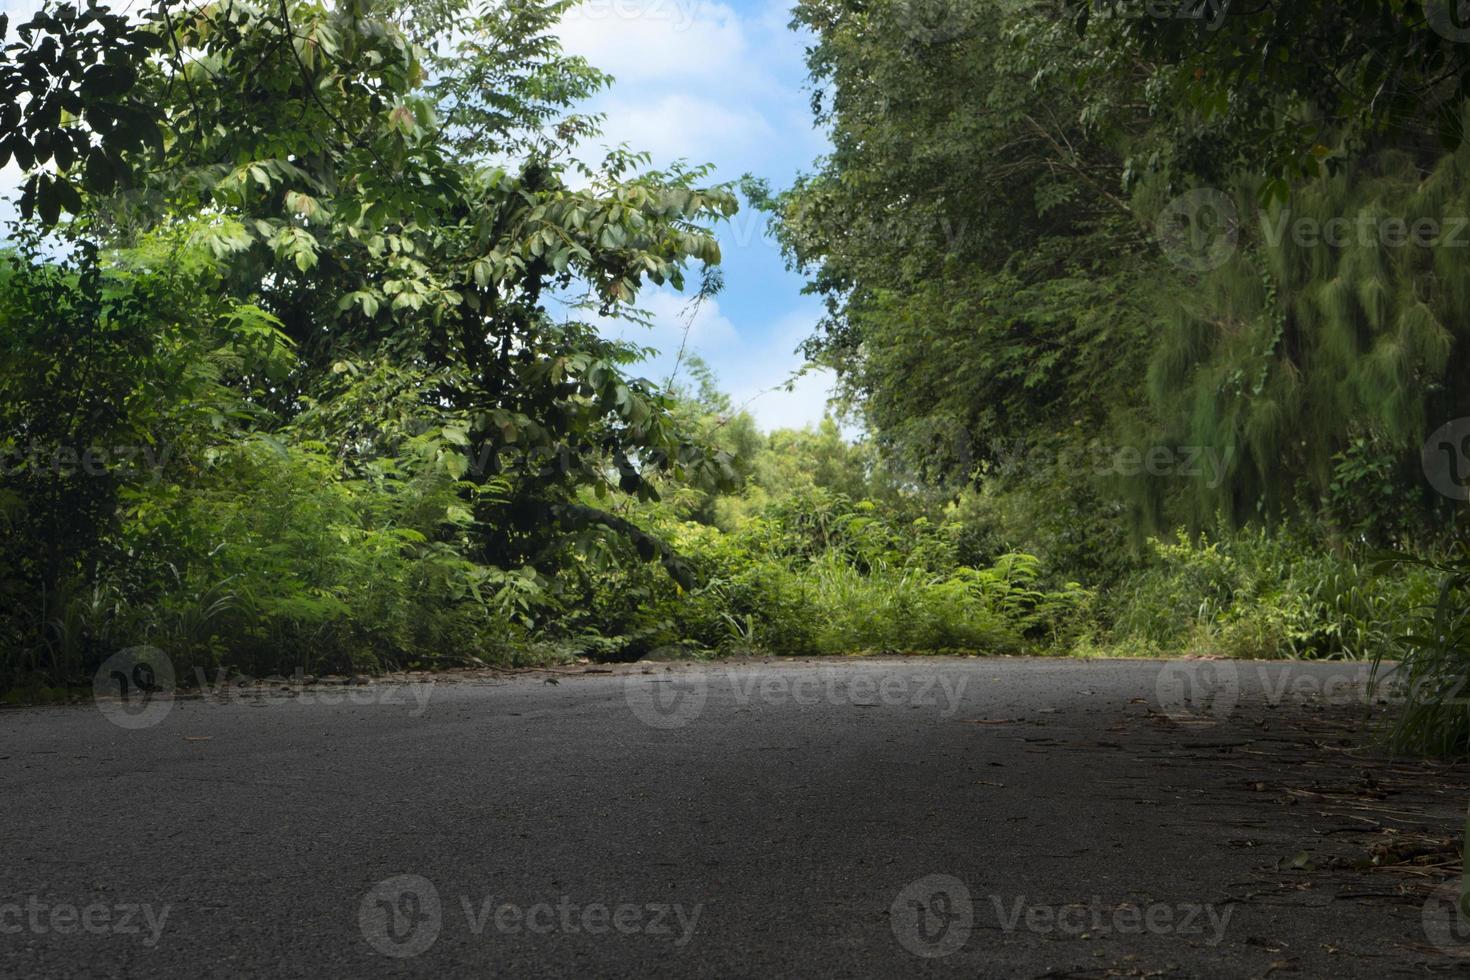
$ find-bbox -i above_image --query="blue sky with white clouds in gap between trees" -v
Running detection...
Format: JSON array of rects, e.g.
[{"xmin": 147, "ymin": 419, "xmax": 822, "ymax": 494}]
[{"xmin": 0, "ymin": 0, "xmax": 831, "ymax": 429}]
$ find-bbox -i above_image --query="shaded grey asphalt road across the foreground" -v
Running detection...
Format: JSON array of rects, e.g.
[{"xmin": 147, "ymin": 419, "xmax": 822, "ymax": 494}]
[{"xmin": 0, "ymin": 658, "xmax": 1470, "ymax": 980}]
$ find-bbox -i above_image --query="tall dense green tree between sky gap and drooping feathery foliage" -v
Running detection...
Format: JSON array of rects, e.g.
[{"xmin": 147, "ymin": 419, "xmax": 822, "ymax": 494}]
[{"xmin": 750, "ymin": 0, "xmax": 1150, "ymax": 486}]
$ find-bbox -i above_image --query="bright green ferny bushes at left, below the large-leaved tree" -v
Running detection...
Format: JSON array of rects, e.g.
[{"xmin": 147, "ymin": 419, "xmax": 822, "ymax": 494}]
[{"xmin": 0, "ymin": 251, "xmax": 544, "ymax": 691}]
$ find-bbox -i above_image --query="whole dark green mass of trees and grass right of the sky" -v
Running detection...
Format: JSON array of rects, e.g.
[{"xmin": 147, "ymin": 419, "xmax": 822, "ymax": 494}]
[{"xmin": 770, "ymin": 0, "xmax": 1470, "ymax": 748}]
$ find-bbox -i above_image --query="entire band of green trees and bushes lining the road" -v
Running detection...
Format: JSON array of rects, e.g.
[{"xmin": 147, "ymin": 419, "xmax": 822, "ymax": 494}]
[{"xmin": 0, "ymin": 0, "xmax": 1470, "ymax": 754}]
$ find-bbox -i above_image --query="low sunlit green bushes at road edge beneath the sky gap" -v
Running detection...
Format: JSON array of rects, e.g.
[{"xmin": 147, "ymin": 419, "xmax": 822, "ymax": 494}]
[{"xmin": 576, "ymin": 491, "xmax": 1091, "ymax": 658}]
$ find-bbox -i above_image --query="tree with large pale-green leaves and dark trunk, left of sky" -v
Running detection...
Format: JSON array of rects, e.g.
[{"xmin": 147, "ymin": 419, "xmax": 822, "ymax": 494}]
[{"xmin": 8, "ymin": 0, "xmax": 746, "ymax": 578}]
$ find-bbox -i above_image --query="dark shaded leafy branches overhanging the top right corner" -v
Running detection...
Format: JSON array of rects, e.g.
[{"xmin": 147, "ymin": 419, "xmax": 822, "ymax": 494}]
[{"xmin": 1064, "ymin": 0, "xmax": 1470, "ymax": 201}]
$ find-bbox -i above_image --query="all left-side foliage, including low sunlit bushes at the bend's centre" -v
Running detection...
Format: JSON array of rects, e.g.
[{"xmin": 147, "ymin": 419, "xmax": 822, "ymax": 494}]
[{"xmin": 0, "ymin": 0, "xmax": 1089, "ymax": 696}]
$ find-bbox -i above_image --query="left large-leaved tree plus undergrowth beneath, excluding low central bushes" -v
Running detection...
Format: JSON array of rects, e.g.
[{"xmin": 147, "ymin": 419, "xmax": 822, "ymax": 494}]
[{"xmin": 0, "ymin": 3, "xmax": 734, "ymax": 690}]
